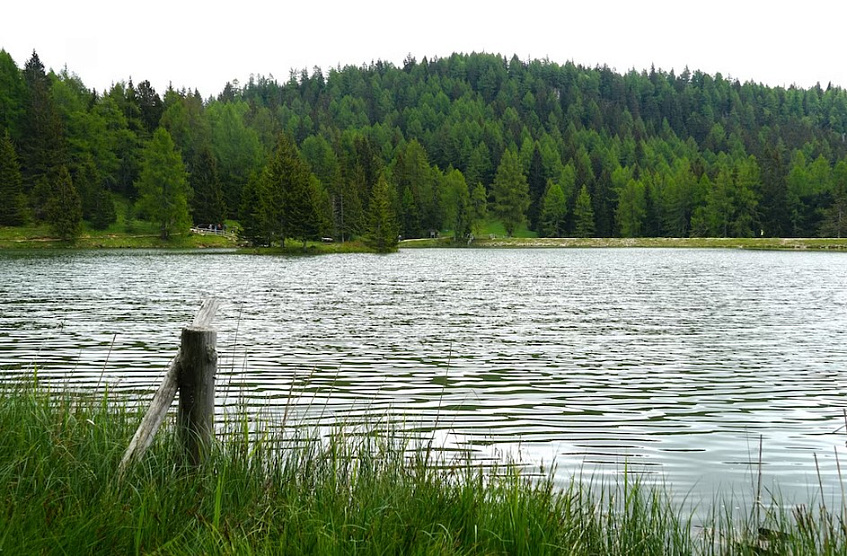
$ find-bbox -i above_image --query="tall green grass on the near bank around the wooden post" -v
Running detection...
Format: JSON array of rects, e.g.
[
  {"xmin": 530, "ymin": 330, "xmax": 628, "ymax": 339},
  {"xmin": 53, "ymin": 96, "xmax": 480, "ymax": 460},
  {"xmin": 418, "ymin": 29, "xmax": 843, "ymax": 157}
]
[{"xmin": 0, "ymin": 385, "xmax": 847, "ymax": 555}]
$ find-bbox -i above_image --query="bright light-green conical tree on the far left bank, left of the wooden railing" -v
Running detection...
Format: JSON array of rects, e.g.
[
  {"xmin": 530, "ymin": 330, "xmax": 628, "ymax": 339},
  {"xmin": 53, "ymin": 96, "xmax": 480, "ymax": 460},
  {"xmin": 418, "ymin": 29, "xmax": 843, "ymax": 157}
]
[{"xmin": 136, "ymin": 127, "xmax": 191, "ymax": 239}]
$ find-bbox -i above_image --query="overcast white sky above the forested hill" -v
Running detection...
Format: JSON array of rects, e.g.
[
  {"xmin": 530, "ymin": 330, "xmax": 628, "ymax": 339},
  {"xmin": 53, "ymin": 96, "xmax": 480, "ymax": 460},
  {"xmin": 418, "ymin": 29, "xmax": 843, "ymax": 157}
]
[{"xmin": 0, "ymin": 0, "xmax": 847, "ymax": 97}]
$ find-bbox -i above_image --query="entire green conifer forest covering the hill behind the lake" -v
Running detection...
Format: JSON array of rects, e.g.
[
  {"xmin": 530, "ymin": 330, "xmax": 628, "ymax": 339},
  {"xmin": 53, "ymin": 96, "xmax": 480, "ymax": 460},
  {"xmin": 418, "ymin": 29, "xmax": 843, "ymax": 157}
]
[{"xmin": 0, "ymin": 50, "xmax": 847, "ymax": 245}]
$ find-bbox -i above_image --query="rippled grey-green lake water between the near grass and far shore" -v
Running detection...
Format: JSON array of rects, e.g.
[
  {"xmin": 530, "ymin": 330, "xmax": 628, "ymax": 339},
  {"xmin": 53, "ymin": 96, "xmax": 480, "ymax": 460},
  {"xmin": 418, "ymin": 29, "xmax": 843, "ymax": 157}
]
[{"xmin": 0, "ymin": 249, "xmax": 847, "ymax": 507}]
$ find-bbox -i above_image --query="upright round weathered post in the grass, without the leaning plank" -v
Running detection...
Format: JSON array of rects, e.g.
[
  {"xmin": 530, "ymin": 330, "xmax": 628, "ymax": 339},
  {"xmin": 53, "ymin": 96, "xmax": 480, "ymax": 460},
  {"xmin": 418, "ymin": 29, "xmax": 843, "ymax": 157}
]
[{"xmin": 177, "ymin": 326, "xmax": 218, "ymax": 465}]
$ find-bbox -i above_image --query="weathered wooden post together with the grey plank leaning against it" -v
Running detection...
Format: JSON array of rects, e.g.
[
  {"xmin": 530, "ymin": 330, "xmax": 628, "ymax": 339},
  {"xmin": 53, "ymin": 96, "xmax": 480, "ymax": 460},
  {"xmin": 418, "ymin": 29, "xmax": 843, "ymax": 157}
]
[{"xmin": 120, "ymin": 298, "xmax": 224, "ymax": 473}]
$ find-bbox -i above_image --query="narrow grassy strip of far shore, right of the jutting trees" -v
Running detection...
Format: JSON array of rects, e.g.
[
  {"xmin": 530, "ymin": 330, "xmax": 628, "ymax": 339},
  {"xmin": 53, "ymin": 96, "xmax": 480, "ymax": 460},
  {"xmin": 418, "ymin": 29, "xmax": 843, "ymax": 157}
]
[{"xmin": 400, "ymin": 236, "xmax": 847, "ymax": 251}]
